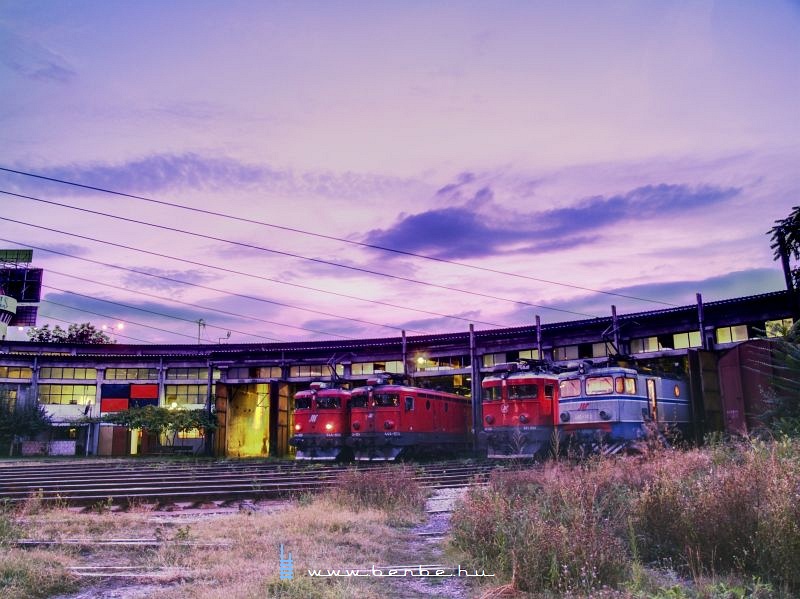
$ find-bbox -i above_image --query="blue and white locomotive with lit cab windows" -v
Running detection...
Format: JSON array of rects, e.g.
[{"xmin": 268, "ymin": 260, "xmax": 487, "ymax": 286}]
[{"xmin": 558, "ymin": 362, "xmax": 692, "ymax": 453}]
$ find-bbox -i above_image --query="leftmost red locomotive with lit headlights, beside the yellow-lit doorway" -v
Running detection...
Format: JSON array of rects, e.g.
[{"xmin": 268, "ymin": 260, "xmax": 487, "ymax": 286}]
[{"xmin": 289, "ymin": 383, "xmax": 350, "ymax": 460}]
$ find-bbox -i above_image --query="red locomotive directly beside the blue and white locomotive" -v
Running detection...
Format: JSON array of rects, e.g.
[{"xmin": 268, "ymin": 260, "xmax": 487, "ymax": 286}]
[{"xmin": 481, "ymin": 362, "xmax": 559, "ymax": 458}]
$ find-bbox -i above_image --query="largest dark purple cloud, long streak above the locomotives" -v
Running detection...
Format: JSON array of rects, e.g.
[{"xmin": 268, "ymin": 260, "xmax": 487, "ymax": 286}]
[{"xmin": 366, "ymin": 184, "xmax": 741, "ymax": 259}]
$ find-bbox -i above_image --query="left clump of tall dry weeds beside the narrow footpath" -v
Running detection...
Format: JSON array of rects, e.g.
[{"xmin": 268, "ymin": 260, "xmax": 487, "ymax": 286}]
[{"xmin": 452, "ymin": 466, "xmax": 629, "ymax": 592}]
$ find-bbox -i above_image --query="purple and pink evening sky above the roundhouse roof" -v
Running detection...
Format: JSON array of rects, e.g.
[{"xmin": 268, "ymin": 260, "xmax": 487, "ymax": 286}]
[{"xmin": 0, "ymin": 0, "xmax": 800, "ymax": 343}]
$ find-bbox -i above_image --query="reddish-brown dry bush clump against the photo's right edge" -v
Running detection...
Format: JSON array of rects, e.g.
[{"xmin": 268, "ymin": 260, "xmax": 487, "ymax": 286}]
[{"xmin": 631, "ymin": 443, "xmax": 800, "ymax": 588}]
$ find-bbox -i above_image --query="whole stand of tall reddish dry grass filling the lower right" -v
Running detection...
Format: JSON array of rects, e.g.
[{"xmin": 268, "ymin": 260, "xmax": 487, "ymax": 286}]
[{"xmin": 452, "ymin": 441, "xmax": 800, "ymax": 596}]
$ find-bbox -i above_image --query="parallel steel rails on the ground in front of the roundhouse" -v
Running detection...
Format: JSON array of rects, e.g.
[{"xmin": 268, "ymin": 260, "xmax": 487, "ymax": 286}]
[{"xmin": 0, "ymin": 461, "xmax": 496, "ymax": 507}]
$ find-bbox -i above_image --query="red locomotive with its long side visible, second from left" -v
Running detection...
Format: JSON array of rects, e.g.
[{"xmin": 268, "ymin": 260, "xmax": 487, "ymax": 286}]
[{"xmin": 347, "ymin": 373, "xmax": 471, "ymax": 460}]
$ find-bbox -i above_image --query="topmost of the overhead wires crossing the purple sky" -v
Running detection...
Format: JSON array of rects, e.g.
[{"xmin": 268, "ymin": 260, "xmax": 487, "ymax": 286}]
[{"xmin": 0, "ymin": 167, "xmax": 677, "ymax": 306}]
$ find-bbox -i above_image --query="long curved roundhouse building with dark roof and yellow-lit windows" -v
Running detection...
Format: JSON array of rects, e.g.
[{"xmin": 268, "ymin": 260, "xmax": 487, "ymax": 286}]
[{"xmin": 0, "ymin": 291, "xmax": 798, "ymax": 457}]
